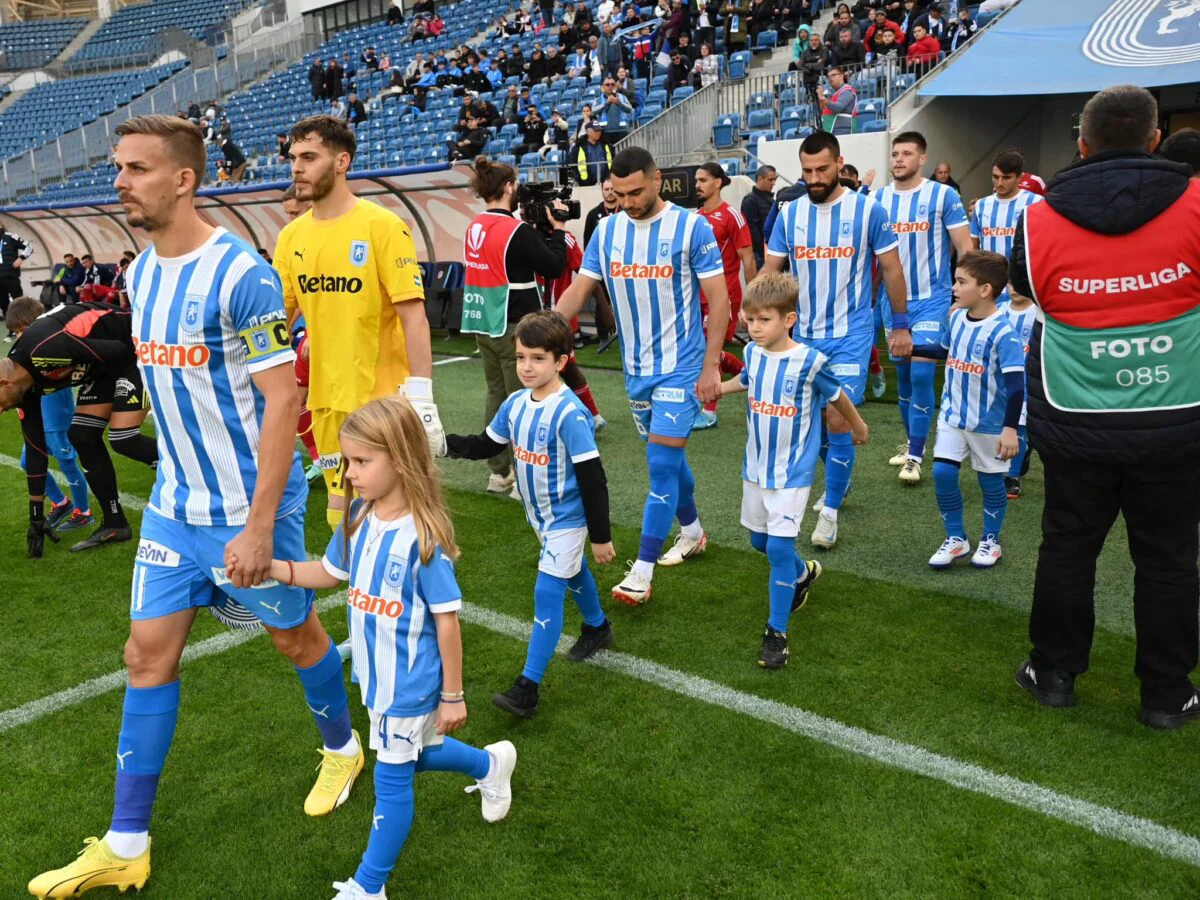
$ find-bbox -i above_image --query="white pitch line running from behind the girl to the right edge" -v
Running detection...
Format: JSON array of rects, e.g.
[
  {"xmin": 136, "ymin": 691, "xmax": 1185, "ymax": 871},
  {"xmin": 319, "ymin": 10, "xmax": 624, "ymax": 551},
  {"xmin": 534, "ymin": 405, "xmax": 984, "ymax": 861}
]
[{"xmin": 461, "ymin": 604, "xmax": 1200, "ymax": 866}]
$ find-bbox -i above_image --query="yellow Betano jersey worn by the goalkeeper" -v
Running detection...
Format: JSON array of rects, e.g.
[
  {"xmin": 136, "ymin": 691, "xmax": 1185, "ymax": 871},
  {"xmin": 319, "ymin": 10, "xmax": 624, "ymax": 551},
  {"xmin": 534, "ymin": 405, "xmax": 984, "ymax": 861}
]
[{"xmin": 275, "ymin": 199, "xmax": 425, "ymax": 413}]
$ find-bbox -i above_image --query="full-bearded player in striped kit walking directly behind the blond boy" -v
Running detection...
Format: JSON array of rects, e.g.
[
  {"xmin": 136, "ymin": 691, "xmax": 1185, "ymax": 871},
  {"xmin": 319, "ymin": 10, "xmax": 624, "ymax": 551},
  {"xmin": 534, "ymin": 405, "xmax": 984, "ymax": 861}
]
[{"xmin": 763, "ymin": 131, "xmax": 912, "ymax": 548}]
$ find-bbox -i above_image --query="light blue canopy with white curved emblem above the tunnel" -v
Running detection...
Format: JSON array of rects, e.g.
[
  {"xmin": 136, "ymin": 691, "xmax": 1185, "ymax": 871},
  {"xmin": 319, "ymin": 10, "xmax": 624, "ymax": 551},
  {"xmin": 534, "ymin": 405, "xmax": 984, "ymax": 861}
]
[{"xmin": 919, "ymin": 0, "xmax": 1200, "ymax": 97}]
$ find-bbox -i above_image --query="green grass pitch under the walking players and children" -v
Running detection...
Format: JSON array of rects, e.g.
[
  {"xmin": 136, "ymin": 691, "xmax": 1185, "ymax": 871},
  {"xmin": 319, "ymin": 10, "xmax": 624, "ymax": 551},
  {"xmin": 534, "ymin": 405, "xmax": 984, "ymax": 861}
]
[{"xmin": 0, "ymin": 346, "xmax": 1200, "ymax": 900}]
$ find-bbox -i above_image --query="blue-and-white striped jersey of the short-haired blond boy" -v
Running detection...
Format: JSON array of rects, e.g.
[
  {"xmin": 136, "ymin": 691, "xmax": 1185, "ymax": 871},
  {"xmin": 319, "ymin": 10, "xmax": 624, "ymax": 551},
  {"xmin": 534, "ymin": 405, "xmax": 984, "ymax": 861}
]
[{"xmin": 740, "ymin": 343, "xmax": 841, "ymax": 490}]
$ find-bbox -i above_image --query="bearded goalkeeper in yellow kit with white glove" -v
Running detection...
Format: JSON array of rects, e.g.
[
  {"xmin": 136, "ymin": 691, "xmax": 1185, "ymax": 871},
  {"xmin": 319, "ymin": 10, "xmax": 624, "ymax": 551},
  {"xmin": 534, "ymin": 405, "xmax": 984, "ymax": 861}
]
[{"xmin": 275, "ymin": 115, "xmax": 445, "ymax": 528}]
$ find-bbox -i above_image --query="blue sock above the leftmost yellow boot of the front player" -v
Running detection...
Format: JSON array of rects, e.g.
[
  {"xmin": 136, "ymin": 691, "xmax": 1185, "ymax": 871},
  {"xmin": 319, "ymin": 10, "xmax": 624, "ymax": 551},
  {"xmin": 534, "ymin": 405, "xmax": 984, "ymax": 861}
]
[{"xmin": 109, "ymin": 678, "xmax": 179, "ymax": 833}]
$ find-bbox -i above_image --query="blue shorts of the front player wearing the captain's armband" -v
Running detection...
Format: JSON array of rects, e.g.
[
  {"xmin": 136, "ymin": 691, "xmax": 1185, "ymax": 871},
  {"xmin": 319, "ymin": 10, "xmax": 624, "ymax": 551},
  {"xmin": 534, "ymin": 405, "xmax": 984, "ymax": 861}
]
[{"xmin": 130, "ymin": 506, "xmax": 313, "ymax": 628}]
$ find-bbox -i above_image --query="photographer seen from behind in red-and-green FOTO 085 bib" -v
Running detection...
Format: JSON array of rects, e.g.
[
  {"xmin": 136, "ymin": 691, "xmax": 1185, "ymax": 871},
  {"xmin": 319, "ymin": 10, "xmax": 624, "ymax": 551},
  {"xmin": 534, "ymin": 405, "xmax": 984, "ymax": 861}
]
[{"xmin": 1010, "ymin": 85, "xmax": 1200, "ymax": 728}]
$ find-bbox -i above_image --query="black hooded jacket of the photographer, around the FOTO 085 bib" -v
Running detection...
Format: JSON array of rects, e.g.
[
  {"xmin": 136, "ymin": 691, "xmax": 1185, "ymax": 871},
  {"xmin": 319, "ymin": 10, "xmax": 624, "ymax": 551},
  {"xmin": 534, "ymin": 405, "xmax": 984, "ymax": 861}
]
[{"xmin": 1009, "ymin": 151, "xmax": 1200, "ymax": 464}]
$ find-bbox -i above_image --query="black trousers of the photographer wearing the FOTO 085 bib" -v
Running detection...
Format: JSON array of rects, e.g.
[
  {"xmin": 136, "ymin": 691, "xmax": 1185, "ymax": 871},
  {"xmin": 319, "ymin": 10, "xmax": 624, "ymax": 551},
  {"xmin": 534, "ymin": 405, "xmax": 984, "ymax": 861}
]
[{"xmin": 1030, "ymin": 455, "xmax": 1200, "ymax": 710}]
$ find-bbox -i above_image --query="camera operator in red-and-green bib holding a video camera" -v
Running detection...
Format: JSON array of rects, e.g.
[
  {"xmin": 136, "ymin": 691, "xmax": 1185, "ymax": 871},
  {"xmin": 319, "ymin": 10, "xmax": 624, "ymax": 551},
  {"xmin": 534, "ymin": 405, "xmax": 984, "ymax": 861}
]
[{"xmin": 462, "ymin": 156, "xmax": 566, "ymax": 493}]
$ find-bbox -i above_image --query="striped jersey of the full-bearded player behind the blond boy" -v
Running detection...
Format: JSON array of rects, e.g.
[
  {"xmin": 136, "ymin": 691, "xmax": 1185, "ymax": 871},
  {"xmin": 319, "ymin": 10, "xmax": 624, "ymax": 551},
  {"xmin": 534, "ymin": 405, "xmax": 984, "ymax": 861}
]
[{"xmin": 767, "ymin": 188, "xmax": 896, "ymax": 341}]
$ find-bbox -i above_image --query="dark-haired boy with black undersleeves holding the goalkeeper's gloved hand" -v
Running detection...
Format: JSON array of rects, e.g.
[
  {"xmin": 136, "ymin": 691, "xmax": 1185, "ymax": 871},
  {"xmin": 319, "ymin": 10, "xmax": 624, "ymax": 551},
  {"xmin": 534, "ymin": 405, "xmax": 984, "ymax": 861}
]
[{"xmin": 446, "ymin": 311, "xmax": 614, "ymax": 719}]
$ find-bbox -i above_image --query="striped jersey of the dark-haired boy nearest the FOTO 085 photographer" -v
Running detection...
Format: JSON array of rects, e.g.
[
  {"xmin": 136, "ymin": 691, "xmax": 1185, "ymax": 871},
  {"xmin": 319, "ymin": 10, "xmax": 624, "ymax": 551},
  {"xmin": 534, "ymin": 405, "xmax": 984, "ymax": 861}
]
[{"xmin": 942, "ymin": 310, "xmax": 1025, "ymax": 434}]
